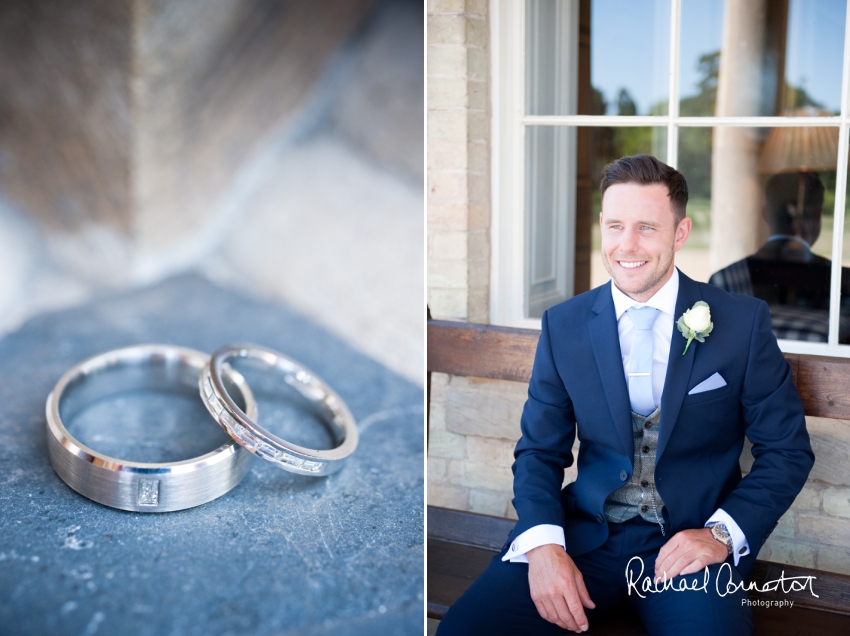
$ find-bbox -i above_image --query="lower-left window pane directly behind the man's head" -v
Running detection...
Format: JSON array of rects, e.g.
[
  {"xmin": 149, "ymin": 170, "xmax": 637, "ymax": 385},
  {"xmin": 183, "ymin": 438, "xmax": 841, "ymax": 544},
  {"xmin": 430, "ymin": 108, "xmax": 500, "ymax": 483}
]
[{"xmin": 524, "ymin": 126, "xmax": 667, "ymax": 318}]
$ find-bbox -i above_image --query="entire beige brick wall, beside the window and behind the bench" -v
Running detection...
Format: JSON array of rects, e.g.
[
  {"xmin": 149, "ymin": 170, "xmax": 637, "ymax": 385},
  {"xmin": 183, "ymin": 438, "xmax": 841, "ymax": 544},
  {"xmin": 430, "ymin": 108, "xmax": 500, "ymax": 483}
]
[{"xmin": 427, "ymin": 0, "xmax": 850, "ymax": 574}]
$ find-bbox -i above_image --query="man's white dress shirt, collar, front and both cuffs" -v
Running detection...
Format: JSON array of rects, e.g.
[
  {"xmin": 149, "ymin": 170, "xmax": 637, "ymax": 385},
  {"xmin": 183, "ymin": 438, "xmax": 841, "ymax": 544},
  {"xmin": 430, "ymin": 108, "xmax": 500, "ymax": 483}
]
[{"xmin": 502, "ymin": 268, "xmax": 750, "ymax": 565}]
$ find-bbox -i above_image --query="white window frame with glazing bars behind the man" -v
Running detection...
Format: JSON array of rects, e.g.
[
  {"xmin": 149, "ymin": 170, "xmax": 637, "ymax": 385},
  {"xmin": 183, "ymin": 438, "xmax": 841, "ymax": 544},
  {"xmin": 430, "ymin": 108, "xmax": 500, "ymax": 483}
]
[{"xmin": 490, "ymin": 0, "xmax": 850, "ymax": 357}]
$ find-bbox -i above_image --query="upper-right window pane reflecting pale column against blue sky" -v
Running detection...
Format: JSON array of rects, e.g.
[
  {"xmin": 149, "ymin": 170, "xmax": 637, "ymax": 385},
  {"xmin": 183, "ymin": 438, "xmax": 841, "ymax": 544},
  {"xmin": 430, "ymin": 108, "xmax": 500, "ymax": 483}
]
[{"xmin": 679, "ymin": 0, "xmax": 845, "ymax": 117}]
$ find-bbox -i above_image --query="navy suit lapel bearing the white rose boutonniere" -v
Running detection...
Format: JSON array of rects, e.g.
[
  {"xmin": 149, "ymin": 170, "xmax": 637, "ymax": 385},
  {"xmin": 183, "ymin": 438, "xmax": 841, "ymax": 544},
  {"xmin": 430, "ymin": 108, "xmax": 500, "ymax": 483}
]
[{"xmin": 656, "ymin": 272, "xmax": 702, "ymax": 463}]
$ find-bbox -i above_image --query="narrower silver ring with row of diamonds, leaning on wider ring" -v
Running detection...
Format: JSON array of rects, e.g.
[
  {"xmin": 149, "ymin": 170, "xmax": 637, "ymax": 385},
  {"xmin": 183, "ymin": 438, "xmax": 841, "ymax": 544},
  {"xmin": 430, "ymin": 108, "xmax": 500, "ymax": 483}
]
[{"xmin": 199, "ymin": 344, "xmax": 358, "ymax": 476}]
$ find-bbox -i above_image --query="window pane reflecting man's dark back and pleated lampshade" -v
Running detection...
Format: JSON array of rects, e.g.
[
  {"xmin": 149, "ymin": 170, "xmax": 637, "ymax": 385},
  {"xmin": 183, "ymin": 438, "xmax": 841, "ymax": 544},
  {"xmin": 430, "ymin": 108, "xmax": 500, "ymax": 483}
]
[{"xmin": 676, "ymin": 127, "xmax": 850, "ymax": 342}]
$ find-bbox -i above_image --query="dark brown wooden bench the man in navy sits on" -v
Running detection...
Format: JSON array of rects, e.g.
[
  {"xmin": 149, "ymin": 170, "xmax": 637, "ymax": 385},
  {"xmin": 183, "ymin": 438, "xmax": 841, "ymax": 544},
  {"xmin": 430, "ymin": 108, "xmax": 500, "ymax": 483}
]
[{"xmin": 427, "ymin": 320, "xmax": 850, "ymax": 636}]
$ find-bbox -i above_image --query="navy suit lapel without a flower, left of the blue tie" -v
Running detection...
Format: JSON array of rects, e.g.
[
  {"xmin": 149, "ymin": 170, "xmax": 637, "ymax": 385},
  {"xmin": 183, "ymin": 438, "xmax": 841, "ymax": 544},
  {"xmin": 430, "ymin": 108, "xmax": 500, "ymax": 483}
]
[{"xmin": 587, "ymin": 283, "xmax": 632, "ymax": 457}]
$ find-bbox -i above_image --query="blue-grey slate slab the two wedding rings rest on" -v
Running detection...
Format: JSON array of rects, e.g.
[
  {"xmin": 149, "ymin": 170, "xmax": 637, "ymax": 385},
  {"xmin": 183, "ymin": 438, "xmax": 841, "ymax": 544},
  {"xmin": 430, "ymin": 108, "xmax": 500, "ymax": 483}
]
[{"xmin": 0, "ymin": 276, "xmax": 424, "ymax": 636}]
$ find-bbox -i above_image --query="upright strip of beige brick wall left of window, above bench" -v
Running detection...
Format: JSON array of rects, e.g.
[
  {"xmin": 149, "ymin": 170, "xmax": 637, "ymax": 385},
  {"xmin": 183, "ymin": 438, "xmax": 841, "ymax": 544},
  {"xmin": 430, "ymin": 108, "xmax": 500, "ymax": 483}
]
[{"xmin": 427, "ymin": 0, "xmax": 490, "ymax": 322}]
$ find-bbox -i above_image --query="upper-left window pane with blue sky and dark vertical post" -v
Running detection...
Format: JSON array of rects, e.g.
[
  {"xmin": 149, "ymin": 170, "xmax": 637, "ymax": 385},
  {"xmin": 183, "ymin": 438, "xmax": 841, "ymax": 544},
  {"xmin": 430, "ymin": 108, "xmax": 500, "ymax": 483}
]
[{"xmin": 526, "ymin": 0, "xmax": 670, "ymax": 115}]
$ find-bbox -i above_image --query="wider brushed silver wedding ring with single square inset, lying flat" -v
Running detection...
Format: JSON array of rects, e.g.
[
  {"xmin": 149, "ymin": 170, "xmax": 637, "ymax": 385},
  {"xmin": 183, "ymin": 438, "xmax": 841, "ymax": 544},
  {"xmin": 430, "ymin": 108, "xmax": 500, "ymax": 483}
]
[{"xmin": 46, "ymin": 345, "xmax": 257, "ymax": 512}]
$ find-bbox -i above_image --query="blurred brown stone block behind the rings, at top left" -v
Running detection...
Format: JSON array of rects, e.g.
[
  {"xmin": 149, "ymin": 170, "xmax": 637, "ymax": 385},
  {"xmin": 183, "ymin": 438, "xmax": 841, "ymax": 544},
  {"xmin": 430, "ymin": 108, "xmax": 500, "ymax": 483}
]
[{"xmin": 0, "ymin": 0, "xmax": 378, "ymax": 248}]
